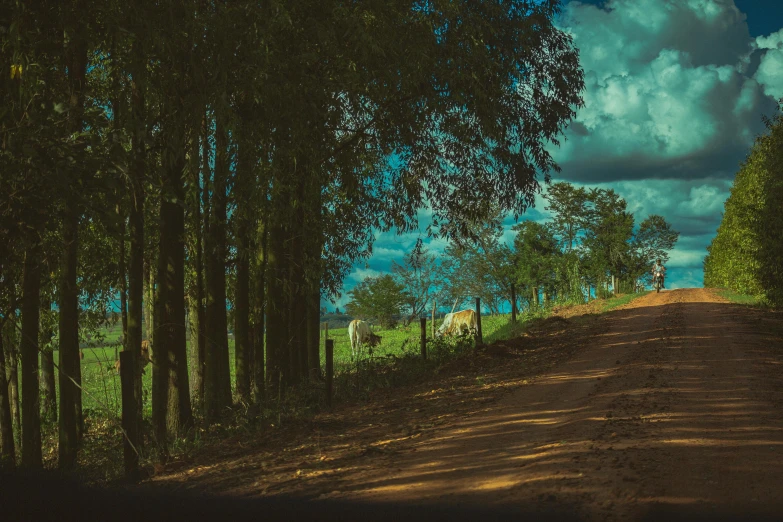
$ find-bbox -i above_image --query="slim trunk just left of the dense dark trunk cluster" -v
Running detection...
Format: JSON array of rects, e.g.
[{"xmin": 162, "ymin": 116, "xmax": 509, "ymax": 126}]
[{"xmin": 253, "ymin": 219, "xmax": 269, "ymax": 404}]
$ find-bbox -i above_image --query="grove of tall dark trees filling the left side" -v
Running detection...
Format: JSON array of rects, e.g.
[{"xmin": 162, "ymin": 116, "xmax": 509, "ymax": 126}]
[{"xmin": 0, "ymin": 0, "xmax": 584, "ymax": 469}]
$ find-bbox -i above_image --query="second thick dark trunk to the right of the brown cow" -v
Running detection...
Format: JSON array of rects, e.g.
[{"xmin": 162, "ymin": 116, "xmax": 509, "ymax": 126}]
[{"xmin": 204, "ymin": 107, "xmax": 231, "ymax": 424}]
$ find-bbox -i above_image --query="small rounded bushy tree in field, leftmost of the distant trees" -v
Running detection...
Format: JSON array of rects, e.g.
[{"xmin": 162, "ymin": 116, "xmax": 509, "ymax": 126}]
[{"xmin": 345, "ymin": 274, "xmax": 408, "ymax": 328}]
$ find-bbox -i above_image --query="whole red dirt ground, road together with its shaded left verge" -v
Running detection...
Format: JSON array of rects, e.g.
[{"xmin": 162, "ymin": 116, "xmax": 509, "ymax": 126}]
[{"xmin": 142, "ymin": 289, "xmax": 783, "ymax": 520}]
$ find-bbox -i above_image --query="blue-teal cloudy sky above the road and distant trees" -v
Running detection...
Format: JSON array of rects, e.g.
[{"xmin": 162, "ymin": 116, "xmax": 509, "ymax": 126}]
[{"xmin": 323, "ymin": 0, "xmax": 783, "ymax": 310}]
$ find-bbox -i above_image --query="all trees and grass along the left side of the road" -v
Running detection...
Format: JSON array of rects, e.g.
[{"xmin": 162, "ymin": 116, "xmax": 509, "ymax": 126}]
[{"xmin": 0, "ymin": 0, "xmax": 678, "ymax": 477}]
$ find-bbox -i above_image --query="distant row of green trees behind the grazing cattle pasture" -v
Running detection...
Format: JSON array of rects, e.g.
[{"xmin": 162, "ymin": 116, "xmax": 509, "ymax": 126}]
[{"xmin": 346, "ymin": 182, "xmax": 679, "ymax": 326}]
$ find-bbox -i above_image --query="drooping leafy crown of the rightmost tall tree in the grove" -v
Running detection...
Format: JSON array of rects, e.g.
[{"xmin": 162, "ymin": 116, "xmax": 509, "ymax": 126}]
[{"xmin": 258, "ymin": 1, "xmax": 583, "ymax": 381}]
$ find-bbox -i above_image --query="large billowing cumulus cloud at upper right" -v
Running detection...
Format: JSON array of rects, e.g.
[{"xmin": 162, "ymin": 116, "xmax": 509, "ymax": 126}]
[{"xmin": 552, "ymin": 0, "xmax": 783, "ymax": 181}]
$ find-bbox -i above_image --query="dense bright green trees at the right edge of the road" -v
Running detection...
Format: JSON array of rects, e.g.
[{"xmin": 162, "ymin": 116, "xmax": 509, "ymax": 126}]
[{"xmin": 704, "ymin": 108, "xmax": 783, "ymax": 306}]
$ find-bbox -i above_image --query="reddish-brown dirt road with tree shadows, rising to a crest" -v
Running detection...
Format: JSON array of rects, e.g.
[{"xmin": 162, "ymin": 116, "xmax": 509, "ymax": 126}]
[{"xmin": 150, "ymin": 289, "xmax": 783, "ymax": 520}]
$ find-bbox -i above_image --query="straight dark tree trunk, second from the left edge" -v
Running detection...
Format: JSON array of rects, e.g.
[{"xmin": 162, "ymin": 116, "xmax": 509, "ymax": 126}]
[{"xmin": 20, "ymin": 244, "xmax": 43, "ymax": 469}]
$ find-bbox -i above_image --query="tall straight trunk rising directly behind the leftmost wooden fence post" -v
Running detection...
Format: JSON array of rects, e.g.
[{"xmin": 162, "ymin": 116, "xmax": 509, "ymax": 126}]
[{"xmin": 125, "ymin": 36, "xmax": 147, "ymax": 443}]
